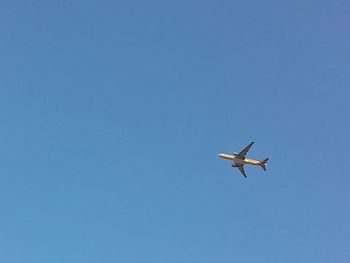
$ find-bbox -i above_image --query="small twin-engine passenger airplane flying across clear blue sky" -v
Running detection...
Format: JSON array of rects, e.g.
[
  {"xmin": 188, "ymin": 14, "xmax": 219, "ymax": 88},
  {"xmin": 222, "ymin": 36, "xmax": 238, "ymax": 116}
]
[{"xmin": 218, "ymin": 142, "xmax": 269, "ymax": 177}]
